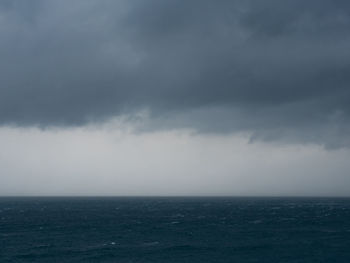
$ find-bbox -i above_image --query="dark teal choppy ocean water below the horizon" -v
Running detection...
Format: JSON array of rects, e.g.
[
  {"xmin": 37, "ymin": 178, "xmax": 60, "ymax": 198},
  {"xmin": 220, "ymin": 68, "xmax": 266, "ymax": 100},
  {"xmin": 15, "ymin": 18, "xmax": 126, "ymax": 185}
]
[{"xmin": 0, "ymin": 198, "xmax": 350, "ymax": 263}]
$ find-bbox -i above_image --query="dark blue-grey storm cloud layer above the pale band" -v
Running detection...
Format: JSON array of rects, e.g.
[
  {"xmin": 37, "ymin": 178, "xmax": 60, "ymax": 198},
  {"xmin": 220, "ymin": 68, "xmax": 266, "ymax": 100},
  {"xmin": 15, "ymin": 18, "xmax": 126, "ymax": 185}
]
[{"xmin": 0, "ymin": 0, "xmax": 350, "ymax": 147}]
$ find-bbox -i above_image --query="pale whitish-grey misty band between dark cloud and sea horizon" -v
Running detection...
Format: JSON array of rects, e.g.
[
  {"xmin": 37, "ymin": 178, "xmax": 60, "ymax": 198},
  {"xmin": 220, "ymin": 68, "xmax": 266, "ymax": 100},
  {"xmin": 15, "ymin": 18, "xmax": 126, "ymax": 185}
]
[{"xmin": 0, "ymin": 124, "xmax": 350, "ymax": 196}]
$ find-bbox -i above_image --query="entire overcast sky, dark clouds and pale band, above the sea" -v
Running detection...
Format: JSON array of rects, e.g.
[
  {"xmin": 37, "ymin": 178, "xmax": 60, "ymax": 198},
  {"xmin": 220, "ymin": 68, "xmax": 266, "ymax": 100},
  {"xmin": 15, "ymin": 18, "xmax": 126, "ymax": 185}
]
[{"xmin": 0, "ymin": 0, "xmax": 350, "ymax": 196}]
